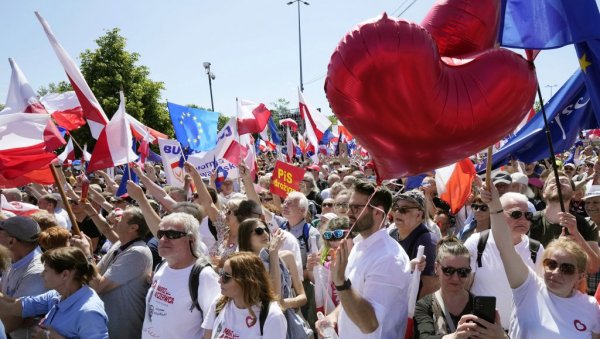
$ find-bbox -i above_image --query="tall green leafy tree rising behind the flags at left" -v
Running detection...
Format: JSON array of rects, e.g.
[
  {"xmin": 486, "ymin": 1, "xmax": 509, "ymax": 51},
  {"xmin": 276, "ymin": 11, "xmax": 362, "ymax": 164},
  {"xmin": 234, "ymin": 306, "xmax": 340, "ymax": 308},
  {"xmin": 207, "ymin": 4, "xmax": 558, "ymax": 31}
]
[{"xmin": 66, "ymin": 28, "xmax": 173, "ymax": 147}]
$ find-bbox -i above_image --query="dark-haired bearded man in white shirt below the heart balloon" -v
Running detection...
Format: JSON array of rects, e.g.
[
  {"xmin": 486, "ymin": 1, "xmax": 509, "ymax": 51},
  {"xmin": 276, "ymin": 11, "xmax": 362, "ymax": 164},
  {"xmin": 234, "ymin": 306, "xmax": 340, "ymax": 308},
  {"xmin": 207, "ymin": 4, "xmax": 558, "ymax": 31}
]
[{"xmin": 317, "ymin": 182, "xmax": 410, "ymax": 338}]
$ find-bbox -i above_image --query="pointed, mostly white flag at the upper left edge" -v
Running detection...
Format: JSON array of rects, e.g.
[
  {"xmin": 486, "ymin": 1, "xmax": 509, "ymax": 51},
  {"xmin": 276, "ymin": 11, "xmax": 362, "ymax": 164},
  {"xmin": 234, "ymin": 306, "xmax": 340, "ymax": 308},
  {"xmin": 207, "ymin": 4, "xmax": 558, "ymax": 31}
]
[{"xmin": 0, "ymin": 58, "xmax": 47, "ymax": 114}]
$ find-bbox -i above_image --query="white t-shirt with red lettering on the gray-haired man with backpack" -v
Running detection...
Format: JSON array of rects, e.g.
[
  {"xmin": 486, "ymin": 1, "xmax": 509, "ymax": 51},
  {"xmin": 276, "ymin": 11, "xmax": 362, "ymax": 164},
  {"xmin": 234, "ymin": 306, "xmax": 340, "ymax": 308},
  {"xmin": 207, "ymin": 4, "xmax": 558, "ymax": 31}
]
[{"xmin": 142, "ymin": 263, "xmax": 221, "ymax": 339}]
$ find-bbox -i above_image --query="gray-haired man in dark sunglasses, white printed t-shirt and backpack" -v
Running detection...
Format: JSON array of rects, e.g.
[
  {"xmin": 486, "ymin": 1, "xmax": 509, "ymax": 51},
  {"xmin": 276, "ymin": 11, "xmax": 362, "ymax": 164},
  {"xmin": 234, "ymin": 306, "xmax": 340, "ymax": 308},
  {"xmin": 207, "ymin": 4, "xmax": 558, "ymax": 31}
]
[{"xmin": 142, "ymin": 213, "xmax": 220, "ymax": 338}]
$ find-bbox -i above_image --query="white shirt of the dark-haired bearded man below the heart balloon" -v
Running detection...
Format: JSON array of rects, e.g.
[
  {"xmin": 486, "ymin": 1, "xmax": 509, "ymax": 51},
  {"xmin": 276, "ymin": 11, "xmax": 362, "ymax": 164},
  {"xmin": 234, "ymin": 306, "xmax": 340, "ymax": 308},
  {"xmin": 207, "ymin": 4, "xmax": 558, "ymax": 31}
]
[{"xmin": 338, "ymin": 229, "xmax": 410, "ymax": 338}]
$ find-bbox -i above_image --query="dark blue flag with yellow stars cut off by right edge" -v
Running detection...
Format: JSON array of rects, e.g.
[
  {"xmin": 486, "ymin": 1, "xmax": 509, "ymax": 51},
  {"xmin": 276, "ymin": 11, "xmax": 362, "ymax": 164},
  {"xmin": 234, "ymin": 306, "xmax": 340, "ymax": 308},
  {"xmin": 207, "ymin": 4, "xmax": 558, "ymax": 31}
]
[{"xmin": 575, "ymin": 39, "xmax": 600, "ymax": 121}]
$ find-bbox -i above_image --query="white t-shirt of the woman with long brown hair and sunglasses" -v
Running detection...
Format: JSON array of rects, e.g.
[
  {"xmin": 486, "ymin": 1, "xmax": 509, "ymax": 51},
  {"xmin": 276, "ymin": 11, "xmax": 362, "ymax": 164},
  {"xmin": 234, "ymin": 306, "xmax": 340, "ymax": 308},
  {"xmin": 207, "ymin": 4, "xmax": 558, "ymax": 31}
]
[{"xmin": 202, "ymin": 296, "xmax": 287, "ymax": 339}]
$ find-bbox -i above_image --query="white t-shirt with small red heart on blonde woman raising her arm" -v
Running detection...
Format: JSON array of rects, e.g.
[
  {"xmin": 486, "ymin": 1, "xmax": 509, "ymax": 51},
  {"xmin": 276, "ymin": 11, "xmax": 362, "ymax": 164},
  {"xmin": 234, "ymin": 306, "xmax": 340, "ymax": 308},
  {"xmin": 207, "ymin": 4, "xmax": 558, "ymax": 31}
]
[{"xmin": 509, "ymin": 269, "xmax": 600, "ymax": 339}]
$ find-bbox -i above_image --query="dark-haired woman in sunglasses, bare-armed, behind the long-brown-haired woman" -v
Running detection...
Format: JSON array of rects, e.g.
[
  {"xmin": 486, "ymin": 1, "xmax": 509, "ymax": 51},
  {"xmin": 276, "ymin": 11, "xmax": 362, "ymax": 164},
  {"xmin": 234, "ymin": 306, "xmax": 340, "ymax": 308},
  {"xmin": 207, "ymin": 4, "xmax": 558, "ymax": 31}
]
[{"xmin": 238, "ymin": 218, "xmax": 306, "ymax": 309}]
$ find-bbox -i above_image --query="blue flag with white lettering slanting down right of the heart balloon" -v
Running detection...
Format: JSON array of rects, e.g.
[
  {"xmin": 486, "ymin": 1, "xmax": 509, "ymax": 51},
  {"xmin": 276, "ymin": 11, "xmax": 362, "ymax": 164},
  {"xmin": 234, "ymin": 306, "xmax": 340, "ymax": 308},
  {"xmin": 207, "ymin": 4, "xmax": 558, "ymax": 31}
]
[{"xmin": 477, "ymin": 70, "xmax": 598, "ymax": 172}]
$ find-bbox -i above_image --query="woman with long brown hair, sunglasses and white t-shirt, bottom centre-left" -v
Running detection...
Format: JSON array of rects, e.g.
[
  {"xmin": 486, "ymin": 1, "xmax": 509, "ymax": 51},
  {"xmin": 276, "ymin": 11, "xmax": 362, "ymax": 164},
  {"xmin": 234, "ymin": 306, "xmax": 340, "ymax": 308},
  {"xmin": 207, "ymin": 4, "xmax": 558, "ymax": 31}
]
[{"xmin": 202, "ymin": 252, "xmax": 287, "ymax": 339}]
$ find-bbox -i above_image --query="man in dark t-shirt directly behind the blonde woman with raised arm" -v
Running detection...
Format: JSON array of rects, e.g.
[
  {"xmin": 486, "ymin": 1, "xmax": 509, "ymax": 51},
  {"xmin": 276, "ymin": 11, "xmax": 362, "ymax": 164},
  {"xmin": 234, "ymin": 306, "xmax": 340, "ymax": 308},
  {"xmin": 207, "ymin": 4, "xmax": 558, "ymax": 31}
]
[{"xmin": 529, "ymin": 172, "xmax": 600, "ymax": 273}]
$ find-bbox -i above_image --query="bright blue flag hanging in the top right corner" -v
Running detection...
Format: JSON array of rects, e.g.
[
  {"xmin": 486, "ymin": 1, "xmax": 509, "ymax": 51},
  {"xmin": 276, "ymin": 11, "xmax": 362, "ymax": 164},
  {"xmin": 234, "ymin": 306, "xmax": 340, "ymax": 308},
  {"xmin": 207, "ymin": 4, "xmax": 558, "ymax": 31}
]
[{"xmin": 498, "ymin": 0, "xmax": 600, "ymax": 49}]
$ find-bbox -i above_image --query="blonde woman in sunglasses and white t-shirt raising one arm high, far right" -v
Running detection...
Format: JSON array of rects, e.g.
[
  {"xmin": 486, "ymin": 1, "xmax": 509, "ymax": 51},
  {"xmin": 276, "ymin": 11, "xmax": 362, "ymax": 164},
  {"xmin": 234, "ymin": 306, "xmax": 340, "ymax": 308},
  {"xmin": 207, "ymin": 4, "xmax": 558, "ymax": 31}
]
[{"xmin": 481, "ymin": 187, "xmax": 600, "ymax": 338}]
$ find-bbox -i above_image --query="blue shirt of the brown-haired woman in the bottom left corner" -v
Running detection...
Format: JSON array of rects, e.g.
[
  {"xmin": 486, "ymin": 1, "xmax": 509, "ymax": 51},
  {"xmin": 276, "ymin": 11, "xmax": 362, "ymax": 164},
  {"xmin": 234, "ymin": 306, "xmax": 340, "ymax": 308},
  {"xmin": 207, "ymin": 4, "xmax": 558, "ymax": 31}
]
[{"xmin": 21, "ymin": 285, "xmax": 108, "ymax": 339}]
